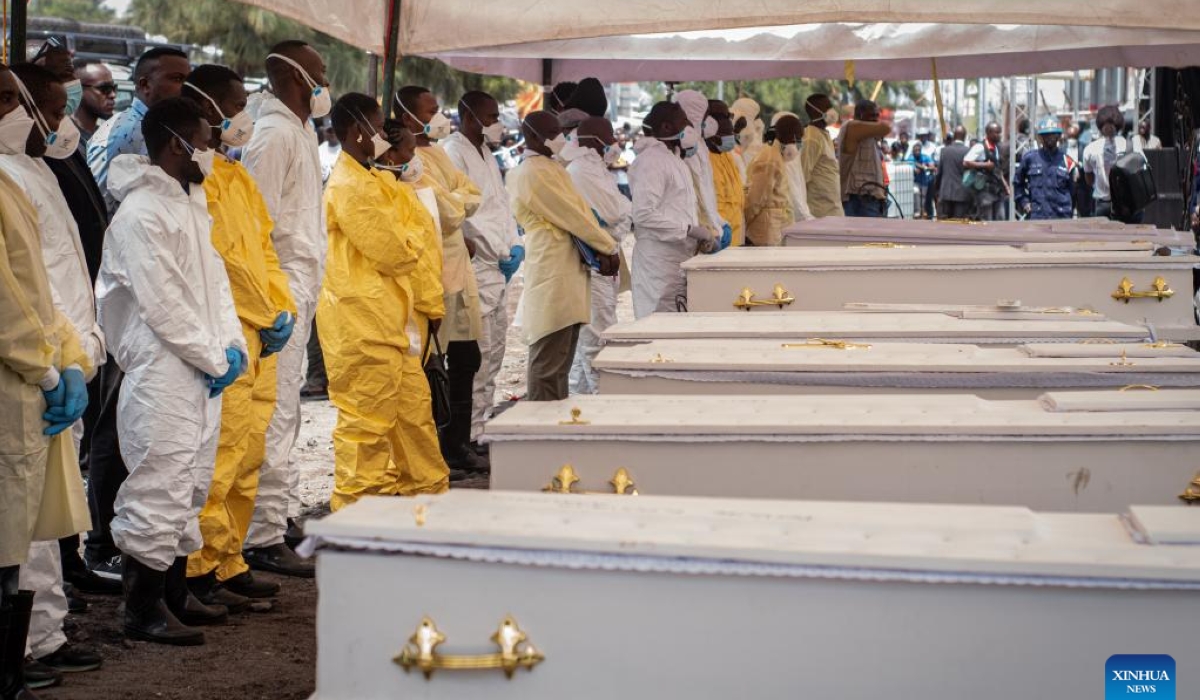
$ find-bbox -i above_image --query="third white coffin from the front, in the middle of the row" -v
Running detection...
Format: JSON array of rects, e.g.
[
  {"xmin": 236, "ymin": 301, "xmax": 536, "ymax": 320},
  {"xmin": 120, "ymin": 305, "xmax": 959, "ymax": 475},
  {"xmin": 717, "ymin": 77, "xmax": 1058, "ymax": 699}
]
[{"xmin": 593, "ymin": 339, "xmax": 1200, "ymax": 399}]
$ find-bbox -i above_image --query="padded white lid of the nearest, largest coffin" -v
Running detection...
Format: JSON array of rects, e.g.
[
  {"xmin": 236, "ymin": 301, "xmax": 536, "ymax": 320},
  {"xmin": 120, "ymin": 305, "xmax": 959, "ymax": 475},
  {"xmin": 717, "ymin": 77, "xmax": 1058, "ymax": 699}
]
[{"xmin": 306, "ymin": 490, "xmax": 1200, "ymax": 581}]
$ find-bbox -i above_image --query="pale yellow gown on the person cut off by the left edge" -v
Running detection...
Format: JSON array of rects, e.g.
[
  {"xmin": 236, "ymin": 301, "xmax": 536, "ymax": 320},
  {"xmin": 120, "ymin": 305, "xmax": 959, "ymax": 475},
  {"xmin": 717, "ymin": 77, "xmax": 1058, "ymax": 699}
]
[{"xmin": 0, "ymin": 168, "xmax": 92, "ymax": 567}]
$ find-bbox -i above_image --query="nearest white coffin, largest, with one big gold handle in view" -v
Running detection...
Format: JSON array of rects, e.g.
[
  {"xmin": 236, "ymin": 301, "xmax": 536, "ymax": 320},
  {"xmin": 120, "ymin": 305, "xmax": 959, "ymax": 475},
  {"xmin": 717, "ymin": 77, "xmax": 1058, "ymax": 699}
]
[{"xmin": 306, "ymin": 490, "xmax": 1200, "ymax": 700}]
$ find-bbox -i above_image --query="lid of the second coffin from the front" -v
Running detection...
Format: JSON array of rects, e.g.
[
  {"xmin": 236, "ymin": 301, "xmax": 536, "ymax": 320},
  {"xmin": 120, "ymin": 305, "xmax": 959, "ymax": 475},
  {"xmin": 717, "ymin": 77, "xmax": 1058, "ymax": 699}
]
[{"xmin": 485, "ymin": 389, "xmax": 1200, "ymax": 441}]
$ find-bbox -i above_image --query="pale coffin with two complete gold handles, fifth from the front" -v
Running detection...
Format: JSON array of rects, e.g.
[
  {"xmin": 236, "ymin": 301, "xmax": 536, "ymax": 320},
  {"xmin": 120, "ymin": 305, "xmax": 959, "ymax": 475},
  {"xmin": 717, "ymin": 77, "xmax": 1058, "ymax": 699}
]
[{"xmin": 683, "ymin": 246, "xmax": 1200, "ymax": 337}]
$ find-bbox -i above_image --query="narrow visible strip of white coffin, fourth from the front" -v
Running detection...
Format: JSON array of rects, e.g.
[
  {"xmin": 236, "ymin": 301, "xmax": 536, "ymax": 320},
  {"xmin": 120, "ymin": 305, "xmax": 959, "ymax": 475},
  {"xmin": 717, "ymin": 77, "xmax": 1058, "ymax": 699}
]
[{"xmin": 604, "ymin": 311, "xmax": 1148, "ymax": 346}]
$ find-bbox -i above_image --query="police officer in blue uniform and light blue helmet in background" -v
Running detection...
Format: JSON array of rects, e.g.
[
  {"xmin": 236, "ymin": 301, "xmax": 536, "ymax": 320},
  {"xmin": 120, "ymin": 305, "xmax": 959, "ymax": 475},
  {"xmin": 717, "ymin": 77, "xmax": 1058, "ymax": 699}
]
[{"xmin": 1013, "ymin": 116, "xmax": 1074, "ymax": 219}]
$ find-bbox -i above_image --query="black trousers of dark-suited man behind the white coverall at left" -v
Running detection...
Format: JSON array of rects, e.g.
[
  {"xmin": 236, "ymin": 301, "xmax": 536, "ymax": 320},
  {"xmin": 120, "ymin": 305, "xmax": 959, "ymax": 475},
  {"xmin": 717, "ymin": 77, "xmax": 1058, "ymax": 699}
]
[{"xmin": 79, "ymin": 357, "xmax": 130, "ymax": 561}]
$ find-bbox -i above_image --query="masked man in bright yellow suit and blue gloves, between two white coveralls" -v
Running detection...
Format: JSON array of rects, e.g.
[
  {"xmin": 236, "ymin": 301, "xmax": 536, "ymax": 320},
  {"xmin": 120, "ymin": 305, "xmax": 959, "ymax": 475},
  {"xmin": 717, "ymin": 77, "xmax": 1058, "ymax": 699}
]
[{"xmin": 184, "ymin": 65, "xmax": 296, "ymax": 609}]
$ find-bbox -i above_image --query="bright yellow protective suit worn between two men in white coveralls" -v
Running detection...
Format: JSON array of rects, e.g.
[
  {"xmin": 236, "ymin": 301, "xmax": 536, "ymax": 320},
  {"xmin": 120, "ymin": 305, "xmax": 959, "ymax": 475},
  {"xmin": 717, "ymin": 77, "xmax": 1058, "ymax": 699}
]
[{"xmin": 187, "ymin": 156, "xmax": 296, "ymax": 581}]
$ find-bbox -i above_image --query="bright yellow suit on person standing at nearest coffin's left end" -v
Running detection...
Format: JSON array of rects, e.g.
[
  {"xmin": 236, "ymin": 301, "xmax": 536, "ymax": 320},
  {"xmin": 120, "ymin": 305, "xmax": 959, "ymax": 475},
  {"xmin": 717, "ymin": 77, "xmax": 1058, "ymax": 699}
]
[{"xmin": 317, "ymin": 151, "xmax": 436, "ymax": 510}]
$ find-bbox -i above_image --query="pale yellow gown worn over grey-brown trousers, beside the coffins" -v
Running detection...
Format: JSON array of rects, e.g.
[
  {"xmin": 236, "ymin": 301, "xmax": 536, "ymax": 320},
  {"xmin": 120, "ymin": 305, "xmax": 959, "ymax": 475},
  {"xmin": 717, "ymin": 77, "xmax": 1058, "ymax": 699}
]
[{"xmin": 508, "ymin": 152, "xmax": 617, "ymax": 345}]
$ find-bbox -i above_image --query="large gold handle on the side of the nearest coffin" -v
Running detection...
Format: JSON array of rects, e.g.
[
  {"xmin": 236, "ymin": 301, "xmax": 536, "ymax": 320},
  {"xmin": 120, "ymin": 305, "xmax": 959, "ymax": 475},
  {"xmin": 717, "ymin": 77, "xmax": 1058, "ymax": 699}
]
[{"xmin": 392, "ymin": 615, "xmax": 546, "ymax": 681}]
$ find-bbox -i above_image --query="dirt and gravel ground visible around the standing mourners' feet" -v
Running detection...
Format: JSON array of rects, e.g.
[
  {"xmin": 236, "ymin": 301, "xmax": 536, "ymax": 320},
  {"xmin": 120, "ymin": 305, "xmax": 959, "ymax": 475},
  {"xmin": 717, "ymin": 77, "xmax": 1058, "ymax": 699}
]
[{"xmin": 37, "ymin": 275, "xmax": 632, "ymax": 700}]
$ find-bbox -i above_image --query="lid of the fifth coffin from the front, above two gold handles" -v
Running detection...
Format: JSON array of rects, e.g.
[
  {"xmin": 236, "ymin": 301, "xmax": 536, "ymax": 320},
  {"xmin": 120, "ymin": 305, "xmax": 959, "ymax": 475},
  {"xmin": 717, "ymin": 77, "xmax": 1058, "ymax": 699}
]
[{"xmin": 683, "ymin": 245, "xmax": 1200, "ymax": 271}]
